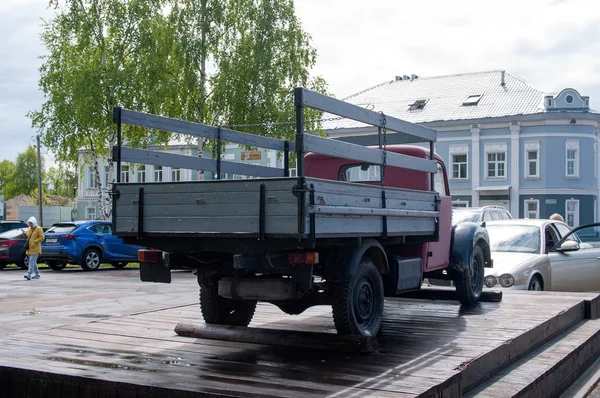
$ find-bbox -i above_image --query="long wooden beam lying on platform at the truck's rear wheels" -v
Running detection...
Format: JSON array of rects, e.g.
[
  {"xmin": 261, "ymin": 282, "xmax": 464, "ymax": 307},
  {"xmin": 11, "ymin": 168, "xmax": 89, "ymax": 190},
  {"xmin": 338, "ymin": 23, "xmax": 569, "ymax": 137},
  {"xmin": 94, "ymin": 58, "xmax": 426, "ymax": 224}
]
[{"xmin": 175, "ymin": 323, "xmax": 379, "ymax": 354}]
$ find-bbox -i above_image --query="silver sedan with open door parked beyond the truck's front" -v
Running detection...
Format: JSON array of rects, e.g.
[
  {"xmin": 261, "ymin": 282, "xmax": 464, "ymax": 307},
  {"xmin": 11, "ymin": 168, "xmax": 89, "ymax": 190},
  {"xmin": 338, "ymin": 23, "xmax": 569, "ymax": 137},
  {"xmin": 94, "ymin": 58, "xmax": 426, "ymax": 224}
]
[{"xmin": 484, "ymin": 219, "xmax": 600, "ymax": 292}]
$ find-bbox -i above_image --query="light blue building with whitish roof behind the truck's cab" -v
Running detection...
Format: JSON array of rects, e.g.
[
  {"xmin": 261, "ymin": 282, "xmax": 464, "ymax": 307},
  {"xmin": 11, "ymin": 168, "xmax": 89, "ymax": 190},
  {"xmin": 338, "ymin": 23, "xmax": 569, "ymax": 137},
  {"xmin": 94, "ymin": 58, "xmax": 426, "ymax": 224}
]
[{"xmin": 324, "ymin": 70, "xmax": 600, "ymax": 226}]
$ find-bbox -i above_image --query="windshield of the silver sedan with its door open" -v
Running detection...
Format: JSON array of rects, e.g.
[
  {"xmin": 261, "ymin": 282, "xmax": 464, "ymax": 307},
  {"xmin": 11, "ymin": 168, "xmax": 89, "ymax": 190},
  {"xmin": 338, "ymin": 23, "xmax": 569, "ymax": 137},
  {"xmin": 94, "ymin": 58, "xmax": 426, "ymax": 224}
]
[{"xmin": 486, "ymin": 224, "xmax": 540, "ymax": 254}]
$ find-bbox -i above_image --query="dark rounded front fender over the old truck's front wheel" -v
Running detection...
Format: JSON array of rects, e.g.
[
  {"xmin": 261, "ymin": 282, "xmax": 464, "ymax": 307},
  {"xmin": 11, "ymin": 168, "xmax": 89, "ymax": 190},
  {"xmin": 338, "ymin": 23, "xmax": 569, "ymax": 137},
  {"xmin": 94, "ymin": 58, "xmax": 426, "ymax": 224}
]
[{"xmin": 450, "ymin": 222, "xmax": 492, "ymax": 274}]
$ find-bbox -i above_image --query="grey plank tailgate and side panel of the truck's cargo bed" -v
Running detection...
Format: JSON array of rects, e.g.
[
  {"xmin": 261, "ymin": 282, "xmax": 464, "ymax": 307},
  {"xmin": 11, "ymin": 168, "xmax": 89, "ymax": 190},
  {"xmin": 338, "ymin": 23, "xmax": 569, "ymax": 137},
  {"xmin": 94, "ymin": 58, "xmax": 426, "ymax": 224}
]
[{"xmin": 114, "ymin": 177, "xmax": 439, "ymax": 240}]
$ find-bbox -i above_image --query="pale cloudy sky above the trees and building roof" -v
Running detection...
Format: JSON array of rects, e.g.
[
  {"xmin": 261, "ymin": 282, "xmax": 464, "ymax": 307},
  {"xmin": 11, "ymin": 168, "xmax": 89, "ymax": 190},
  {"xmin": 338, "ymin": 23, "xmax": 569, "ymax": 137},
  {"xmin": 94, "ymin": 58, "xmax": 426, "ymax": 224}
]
[{"xmin": 0, "ymin": 0, "xmax": 600, "ymax": 168}]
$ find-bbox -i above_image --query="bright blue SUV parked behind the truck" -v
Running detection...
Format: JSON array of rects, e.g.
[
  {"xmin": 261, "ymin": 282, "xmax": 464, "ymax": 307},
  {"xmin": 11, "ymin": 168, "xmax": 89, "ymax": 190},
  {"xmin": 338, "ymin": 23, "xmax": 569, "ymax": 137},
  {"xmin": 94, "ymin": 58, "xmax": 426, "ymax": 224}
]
[{"xmin": 39, "ymin": 221, "xmax": 143, "ymax": 271}]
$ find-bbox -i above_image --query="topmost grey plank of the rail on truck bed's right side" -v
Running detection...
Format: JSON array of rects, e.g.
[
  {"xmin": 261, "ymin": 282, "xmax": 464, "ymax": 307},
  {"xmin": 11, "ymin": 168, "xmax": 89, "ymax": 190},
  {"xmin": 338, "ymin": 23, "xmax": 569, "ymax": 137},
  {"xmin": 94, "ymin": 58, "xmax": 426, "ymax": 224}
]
[{"xmin": 295, "ymin": 88, "xmax": 437, "ymax": 142}]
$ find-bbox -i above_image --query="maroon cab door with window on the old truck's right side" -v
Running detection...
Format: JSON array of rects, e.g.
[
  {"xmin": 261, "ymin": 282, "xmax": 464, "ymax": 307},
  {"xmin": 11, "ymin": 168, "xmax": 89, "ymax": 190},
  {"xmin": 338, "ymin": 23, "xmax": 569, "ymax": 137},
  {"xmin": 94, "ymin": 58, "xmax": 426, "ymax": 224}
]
[{"xmin": 425, "ymin": 161, "xmax": 452, "ymax": 271}]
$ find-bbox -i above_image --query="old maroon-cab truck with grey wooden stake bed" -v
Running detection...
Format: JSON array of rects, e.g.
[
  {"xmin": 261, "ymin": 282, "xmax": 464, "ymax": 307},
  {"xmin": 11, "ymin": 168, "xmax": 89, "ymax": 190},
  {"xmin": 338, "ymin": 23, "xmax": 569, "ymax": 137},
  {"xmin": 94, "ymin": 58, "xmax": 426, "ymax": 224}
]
[{"xmin": 112, "ymin": 88, "xmax": 491, "ymax": 336}]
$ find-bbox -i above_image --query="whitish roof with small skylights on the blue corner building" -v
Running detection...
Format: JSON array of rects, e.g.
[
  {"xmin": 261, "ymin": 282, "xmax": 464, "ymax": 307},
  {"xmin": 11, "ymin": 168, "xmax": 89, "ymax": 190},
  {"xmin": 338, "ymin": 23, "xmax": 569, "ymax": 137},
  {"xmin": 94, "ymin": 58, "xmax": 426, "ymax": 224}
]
[{"xmin": 323, "ymin": 70, "xmax": 546, "ymax": 130}]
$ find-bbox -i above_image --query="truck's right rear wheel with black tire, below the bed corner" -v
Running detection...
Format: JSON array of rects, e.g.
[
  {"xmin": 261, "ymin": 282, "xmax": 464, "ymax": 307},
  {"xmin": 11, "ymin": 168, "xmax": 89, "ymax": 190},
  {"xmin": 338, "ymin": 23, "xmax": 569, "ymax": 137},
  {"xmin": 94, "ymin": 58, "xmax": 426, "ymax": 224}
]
[{"xmin": 331, "ymin": 257, "xmax": 383, "ymax": 336}]
